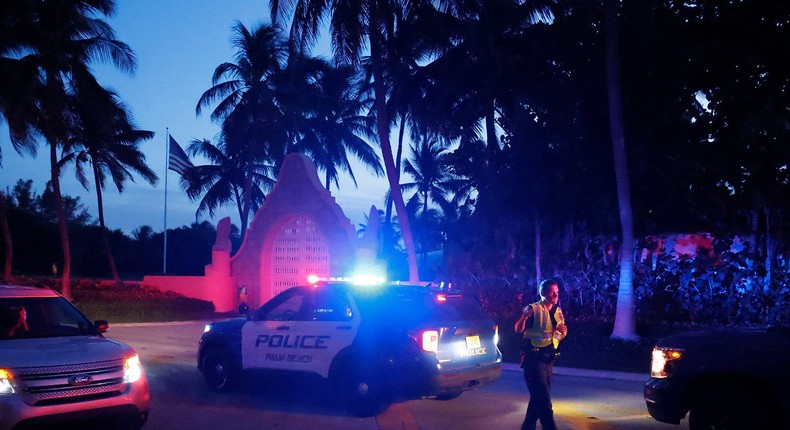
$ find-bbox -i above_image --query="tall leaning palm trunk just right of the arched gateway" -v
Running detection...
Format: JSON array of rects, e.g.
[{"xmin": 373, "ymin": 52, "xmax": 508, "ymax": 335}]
[{"xmin": 369, "ymin": 10, "xmax": 420, "ymax": 282}]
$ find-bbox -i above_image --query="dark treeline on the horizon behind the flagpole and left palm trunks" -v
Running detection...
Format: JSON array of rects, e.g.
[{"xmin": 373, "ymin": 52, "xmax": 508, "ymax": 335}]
[{"xmin": 0, "ymin": 180, "xmax": 220, "ymax": 280}]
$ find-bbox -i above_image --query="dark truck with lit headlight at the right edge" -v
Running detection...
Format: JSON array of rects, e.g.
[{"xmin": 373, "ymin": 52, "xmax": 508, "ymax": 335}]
[{"xmin": 644, "ymin": 305, "xmax": 790, "ymax": 430}]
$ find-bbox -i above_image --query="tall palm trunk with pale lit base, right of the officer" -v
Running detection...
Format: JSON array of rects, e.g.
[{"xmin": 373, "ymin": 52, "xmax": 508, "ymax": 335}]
[{"xmin": 604, "ymin": 0, "xmax": 639, "ymax": 340}]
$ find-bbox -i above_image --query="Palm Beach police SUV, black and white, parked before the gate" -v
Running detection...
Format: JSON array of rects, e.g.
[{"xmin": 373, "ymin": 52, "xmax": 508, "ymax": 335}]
[{"xmin": 197, "ymin": 281, "xmax": 502, "ymax": 416}]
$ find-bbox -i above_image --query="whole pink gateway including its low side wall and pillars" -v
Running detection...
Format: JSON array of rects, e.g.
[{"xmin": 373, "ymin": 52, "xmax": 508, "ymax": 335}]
[{"xmin": 143, "ymin": 154, "xmax": 377, "ymax": 312}]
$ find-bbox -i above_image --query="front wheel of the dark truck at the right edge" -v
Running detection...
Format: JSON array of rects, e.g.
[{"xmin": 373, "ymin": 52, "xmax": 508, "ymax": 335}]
[{"xmin": 689, "ymin": 389, "xmax": 775, "ymax": 430}]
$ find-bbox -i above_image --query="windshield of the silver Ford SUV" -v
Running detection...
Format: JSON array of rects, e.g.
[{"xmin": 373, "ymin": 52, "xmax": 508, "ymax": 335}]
[{"xmin": 0, "ymin": 297, "xmax": 98, "ymax": 340}]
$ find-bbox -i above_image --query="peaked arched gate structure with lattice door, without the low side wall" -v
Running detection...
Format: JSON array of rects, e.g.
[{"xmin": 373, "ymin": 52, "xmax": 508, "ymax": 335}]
[{"xmin": 230, "ymin": 154, "xmax": 357, "ymax": 307}]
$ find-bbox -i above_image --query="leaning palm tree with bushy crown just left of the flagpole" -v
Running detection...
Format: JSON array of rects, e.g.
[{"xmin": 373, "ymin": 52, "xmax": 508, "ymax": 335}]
[{"xmin": 63, "ymin": 74, "xmax": 159, "ymax": 283}]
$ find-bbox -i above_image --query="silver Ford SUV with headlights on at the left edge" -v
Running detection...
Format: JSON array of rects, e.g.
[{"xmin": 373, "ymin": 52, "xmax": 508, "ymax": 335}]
[{"xmin": 0, "ymin": 285, "xmax": 150, "ymax": 430}]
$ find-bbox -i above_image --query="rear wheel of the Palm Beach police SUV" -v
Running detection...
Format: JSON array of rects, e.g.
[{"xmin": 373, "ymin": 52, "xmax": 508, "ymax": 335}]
[{"xmin": 336, "ymin": 363, "xmax": 391, "ymax": 417}]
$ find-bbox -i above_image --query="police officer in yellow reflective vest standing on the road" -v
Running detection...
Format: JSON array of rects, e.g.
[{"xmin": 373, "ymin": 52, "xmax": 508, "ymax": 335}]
[{"xmin": 515, "ymin": 279, "xmax": 568, "ymax": 430}]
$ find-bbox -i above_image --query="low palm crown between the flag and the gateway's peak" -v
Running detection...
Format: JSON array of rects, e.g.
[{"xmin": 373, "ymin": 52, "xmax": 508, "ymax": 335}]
[{"xmin": 181, "ymin": 139, "xmax": 275, "ymax": 234}]
